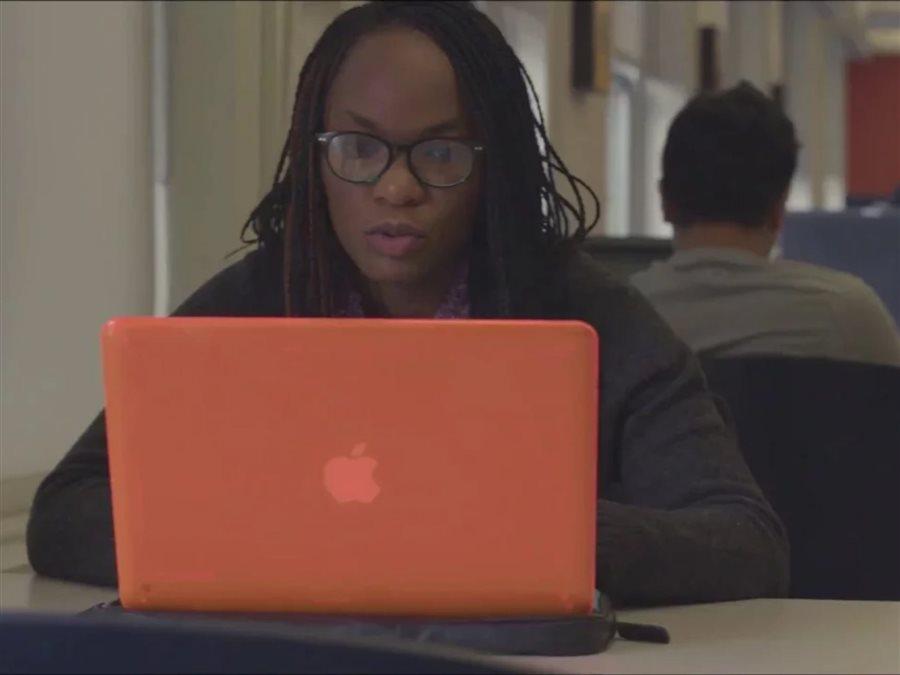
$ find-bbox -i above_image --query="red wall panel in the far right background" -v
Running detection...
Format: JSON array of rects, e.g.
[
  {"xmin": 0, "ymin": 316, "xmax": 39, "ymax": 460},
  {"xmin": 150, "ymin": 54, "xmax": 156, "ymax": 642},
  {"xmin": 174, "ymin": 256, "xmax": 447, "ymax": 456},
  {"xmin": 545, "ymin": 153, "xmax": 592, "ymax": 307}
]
[{"xmin": 847, "ymin": 55, "xmax": 900, "ymax": 196}]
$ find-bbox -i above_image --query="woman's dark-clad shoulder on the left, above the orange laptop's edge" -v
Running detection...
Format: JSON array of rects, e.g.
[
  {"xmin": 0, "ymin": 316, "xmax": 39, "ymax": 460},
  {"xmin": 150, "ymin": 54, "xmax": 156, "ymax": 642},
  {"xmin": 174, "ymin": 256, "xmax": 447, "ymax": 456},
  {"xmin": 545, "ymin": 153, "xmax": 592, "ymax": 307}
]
[{"xmin": 172, "ymin": 247, "xmax": 284, "ymax": 316}]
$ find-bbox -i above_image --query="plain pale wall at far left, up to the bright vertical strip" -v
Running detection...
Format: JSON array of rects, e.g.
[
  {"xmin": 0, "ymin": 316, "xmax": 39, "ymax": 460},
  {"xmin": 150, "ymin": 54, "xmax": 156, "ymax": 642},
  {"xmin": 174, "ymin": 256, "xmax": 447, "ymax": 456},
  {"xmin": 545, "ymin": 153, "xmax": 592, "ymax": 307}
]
[{"xmin": 0, "ymin": 2, "xmax": 153, "ymax": 492}]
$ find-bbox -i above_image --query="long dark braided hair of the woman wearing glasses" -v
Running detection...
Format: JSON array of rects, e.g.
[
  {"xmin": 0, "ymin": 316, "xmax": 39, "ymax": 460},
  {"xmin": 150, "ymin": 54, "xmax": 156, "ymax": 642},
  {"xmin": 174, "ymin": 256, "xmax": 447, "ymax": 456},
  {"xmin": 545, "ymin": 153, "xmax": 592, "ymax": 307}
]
[{"xmin": 242, "ymin": 0, "xmax": 599, "ymax": 317}]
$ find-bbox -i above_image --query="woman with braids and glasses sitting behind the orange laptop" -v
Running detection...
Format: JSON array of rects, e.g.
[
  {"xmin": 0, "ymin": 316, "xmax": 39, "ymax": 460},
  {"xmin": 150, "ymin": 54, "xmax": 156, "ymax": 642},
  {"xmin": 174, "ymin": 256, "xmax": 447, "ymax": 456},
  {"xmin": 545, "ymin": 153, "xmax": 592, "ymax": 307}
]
[{"xmin": 28, "ymin": 2, "xmax": 787, "ymax": 604}]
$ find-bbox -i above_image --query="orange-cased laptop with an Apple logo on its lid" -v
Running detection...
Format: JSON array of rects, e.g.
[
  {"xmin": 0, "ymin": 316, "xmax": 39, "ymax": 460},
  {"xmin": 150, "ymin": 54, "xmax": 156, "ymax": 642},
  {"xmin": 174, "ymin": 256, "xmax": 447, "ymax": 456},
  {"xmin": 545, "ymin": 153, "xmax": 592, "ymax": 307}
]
[{"xmin": 102, "ymin": 317, "xmax": 599, "ymax": 617}]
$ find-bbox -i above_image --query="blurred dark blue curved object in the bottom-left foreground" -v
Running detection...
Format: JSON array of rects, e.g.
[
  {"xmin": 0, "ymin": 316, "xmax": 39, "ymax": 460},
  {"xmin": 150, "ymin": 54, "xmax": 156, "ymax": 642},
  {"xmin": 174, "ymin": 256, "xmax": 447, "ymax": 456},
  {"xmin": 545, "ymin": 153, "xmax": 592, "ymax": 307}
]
[{"xmin": 0, "ymin": 614, "xmax": 513, "ymax": 673}]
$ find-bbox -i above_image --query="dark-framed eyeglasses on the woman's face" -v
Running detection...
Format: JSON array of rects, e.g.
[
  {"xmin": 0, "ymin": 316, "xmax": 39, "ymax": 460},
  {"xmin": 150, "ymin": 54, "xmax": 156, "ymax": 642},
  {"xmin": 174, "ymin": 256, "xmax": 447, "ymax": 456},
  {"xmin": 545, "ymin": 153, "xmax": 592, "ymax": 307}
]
[{"xmin": 315, "ymin": 131, "xmax": 484, "ymax": 188}]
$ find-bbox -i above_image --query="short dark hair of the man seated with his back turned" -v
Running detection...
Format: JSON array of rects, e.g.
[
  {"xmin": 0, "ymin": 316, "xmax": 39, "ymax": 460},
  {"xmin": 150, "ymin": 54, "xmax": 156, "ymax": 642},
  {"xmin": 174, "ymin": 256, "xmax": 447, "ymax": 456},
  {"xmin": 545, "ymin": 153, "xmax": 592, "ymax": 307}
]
[{"xmin": 661, "ymin": 81, "xmax": 800, "ymax": 227}]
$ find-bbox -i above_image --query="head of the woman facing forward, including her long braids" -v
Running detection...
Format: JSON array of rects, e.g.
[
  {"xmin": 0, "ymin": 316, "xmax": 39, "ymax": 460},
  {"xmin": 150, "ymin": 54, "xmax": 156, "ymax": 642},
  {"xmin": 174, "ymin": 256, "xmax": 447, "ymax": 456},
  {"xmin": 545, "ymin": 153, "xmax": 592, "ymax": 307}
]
[{"xmin": 244, "ymin": 2, "xmax": 593, "ymax": 316}]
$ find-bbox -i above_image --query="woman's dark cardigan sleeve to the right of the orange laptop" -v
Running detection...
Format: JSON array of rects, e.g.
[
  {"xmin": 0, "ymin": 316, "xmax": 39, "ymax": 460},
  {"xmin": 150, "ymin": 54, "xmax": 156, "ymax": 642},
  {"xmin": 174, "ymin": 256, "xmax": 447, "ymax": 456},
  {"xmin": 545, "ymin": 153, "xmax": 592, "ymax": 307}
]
[{"xmin": 571, "ymin": 258, "xmax": 789, "ymax": 605}]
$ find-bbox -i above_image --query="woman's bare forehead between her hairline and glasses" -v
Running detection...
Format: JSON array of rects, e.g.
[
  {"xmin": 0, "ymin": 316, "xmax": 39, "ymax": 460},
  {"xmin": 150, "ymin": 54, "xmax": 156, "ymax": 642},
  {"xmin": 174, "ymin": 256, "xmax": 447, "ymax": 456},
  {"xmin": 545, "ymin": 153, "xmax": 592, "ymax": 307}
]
[{"xmin": 325, "ymin": 28, "xmax": 469, "ymax": 140}]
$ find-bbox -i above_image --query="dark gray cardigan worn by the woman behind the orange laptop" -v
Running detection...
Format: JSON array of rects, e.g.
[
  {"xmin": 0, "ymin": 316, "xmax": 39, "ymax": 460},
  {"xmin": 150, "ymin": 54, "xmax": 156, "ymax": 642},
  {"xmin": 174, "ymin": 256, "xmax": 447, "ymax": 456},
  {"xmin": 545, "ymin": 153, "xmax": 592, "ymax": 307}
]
[{"xmin": 27, "ymin": 250, "xmax": 788, "ymax": 605}]
